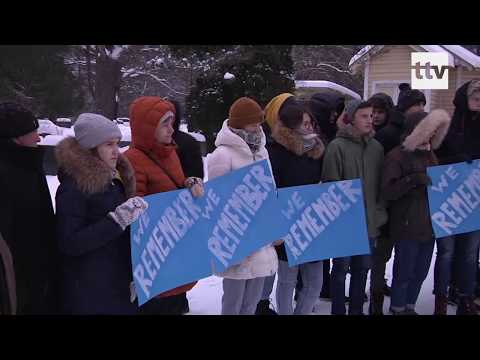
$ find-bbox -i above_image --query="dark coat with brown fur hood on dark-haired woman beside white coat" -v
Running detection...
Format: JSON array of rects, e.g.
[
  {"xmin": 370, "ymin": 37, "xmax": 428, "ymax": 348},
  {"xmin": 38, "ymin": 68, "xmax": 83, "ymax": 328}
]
[{"xmin": 267, "ymin": 121, "xmax": 325, "ymax": 261}]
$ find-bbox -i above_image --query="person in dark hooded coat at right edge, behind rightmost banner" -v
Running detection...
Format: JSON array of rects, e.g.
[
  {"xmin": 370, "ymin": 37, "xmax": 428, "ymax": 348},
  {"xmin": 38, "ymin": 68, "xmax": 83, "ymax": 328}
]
[{"xmin": 433, "ymin": 80, "xmax": 480, "ymax": 315}]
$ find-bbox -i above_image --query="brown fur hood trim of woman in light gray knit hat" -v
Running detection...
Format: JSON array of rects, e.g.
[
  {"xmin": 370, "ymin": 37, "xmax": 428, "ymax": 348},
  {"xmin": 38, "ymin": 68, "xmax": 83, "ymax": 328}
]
[{"xmin": 55, "ymin": 137, "xmax": 136, "ymax": 198}]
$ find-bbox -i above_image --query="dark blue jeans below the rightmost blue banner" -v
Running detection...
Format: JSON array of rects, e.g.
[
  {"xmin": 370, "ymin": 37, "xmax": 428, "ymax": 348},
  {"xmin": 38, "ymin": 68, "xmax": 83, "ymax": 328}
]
[{"xmin": 433, "ymin": 231, "xmax": 480, "ymax": 296}]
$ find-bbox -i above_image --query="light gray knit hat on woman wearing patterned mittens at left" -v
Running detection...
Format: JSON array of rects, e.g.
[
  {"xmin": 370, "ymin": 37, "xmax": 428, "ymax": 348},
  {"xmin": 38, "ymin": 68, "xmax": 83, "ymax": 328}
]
[{"xmin": 73, "ymin": 113, "xmax": 122, "ymax": 149}]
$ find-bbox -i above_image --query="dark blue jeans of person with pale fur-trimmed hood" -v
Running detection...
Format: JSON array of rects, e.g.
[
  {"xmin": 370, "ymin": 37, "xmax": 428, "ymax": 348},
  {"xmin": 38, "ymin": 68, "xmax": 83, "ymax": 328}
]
[{"xmin": 390, "ymin": 239, "xmax": 435, "ymax": 311}]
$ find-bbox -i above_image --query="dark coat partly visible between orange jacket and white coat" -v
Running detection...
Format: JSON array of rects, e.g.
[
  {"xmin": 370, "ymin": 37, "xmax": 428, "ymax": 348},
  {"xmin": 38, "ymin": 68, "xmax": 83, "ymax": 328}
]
[{"xmin": 173, "ymin": 130, "xmax": 204, "ymax": 179}]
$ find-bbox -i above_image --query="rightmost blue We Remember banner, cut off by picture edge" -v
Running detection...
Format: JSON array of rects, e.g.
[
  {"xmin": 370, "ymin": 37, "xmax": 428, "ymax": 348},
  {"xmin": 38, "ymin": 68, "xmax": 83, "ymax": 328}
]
[{"xmin": 427, "ymin": 160, "xmax": 480, "ymax": 238}]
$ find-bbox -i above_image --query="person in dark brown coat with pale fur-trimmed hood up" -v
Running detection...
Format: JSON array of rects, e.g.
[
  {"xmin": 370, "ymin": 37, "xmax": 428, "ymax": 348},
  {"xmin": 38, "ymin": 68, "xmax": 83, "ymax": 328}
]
[{"xmin": 381, "ymin": 110, "xmax": 450, "ymax": 315}]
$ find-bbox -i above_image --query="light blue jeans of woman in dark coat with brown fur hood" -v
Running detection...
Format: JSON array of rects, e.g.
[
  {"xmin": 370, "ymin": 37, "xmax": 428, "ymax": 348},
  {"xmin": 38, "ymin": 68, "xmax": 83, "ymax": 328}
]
[{"xmin": 276, "ymin": 260, "xmax": 323, "ymax": 315}]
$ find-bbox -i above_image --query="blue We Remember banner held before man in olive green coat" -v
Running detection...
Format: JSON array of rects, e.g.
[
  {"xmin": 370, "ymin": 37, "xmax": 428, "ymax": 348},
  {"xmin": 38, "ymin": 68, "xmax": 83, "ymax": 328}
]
[{"xmin": 277, "ymin": 179, "xmax": 370, "ymax": 266}]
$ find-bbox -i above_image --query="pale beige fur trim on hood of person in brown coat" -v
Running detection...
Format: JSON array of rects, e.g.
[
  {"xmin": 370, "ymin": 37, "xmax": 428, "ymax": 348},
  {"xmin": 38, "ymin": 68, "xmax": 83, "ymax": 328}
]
[{"xmin": 402, "ymin": 109, "xmax": 451, "ymax": 152}]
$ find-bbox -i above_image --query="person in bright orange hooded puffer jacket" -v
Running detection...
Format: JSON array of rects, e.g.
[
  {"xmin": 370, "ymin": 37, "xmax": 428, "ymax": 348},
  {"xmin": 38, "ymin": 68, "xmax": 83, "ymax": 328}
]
[{"xmin": 125, "ymin": 96, "xmax": 203, "ymax": 315}]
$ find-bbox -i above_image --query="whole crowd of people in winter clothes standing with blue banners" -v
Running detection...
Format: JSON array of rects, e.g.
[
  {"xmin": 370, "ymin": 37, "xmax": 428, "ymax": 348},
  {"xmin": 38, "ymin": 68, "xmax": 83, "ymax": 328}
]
[{"xmin": 0, "ymin": 80, "xmax": 480, "ymax": 315}]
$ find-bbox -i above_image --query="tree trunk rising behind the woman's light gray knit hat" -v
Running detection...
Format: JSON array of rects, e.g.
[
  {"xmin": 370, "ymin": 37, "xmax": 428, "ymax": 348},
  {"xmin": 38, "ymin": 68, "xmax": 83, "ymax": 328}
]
[{"xmin": 95, "ymin": 53, "xmax": 121, "ymax": 120}]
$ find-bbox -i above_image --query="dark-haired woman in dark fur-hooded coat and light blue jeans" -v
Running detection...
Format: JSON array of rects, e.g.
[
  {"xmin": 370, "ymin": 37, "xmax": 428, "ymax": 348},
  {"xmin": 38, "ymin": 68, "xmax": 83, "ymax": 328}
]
[{"xmin": 269, "ymin": 98, "xmax": 325, "ymax": 315}]
